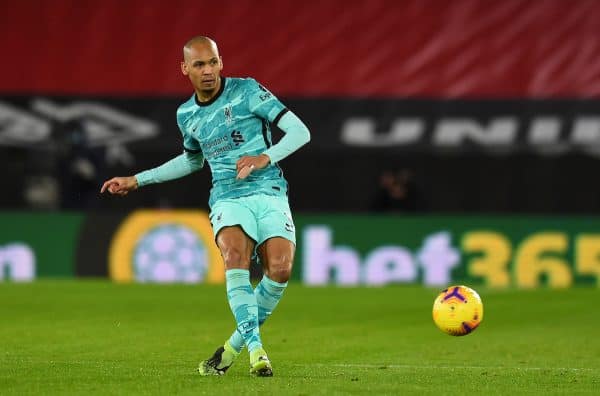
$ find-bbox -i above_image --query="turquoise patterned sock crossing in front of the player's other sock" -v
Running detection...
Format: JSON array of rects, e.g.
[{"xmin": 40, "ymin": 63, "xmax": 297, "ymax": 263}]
[{"xmin": 225, "ymin": 269, "xmax": 262, "ymax": 351}]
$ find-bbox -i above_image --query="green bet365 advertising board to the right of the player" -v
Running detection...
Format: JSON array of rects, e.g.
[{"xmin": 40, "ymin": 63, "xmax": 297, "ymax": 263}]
[{"xmin": 296, "ymin": 215, "xmax": 600, "ymax": 288}]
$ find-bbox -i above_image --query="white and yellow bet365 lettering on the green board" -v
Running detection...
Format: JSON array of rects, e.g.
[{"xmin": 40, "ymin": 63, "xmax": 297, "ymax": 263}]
[{"xmin": 302, "ymin": 225, "xmax": 600, "ymax": 288}]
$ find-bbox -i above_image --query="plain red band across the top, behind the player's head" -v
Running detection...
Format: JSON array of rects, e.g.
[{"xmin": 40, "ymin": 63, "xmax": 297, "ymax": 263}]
[{"xmin": 0, "ymin": 0, "xmax": 600, "ymax": 98}]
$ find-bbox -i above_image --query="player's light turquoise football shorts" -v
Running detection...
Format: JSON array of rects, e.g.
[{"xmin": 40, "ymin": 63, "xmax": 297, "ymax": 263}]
[{"xmin": 209, "ymin": 194, "xmax": 296, "ymax": 246}]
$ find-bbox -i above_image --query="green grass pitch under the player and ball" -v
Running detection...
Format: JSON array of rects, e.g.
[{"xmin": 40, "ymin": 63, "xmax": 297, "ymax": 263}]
[{"xmin": 0, "ymin": 281, "xmax": 600, "ymax": 395}]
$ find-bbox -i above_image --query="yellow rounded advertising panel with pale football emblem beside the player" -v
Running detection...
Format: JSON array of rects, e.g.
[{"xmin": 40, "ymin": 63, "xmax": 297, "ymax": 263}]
[{"xmin": 109, "ymin": 210, "xmax": 225, "ymax": 283}]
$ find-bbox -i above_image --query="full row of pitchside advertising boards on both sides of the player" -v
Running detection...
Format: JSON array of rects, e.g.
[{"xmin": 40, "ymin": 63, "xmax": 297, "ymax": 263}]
[{"xmin": 0, "ymin": 210, "xmax": 600, "ymax": 288}]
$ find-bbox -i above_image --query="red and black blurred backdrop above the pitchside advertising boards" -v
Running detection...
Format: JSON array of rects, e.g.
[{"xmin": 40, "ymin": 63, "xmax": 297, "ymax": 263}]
[{"xmin": 0, "ymin": 0, "xmax": 600, "ymax": 214}]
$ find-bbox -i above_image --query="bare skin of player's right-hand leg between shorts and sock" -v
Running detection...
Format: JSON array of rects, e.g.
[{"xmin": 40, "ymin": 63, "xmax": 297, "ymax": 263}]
[{"xmin": 258, "ymin": 237, "xmax": 296, "ymax": 282}]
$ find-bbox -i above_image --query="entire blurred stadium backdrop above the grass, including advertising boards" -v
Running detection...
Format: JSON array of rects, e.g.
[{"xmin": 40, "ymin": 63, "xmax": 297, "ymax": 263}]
[{"xmin": 0, "ymin": 0, "xmax": 600, "ymax": 287}]
